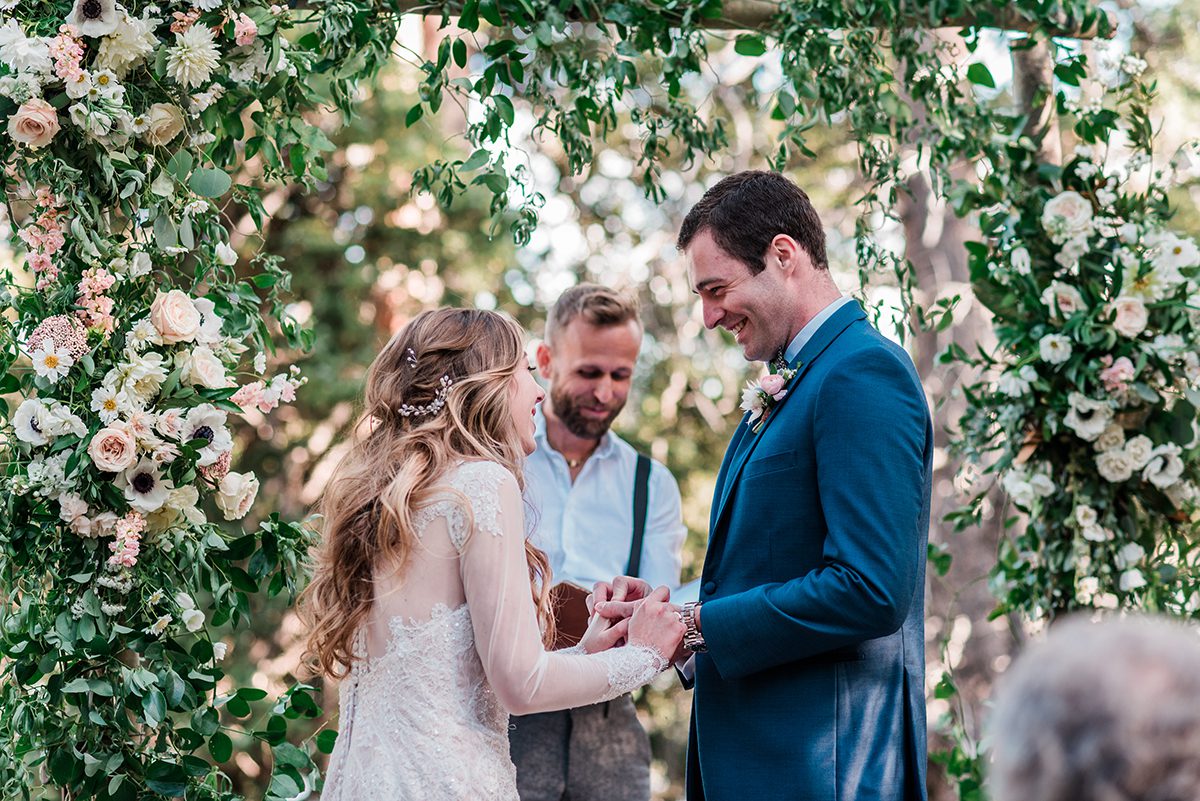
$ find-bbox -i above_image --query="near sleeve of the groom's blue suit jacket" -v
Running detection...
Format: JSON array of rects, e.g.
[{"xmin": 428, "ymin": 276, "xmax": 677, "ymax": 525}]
[{"xmin": 701, "ymin": 348, "xmax": 929, "ymax": 679}]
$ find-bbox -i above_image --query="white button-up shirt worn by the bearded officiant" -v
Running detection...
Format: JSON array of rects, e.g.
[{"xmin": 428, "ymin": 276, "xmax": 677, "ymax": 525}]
[{"xmin": 524, "ymin": 408, "xmax": 688, "ymax": 590}]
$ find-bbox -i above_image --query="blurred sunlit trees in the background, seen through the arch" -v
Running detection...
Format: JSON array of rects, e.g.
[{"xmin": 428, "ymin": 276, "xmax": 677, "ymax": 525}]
[{"xmin": 206, "ymin": 0, "xmax": 1200, "ymax": 799}]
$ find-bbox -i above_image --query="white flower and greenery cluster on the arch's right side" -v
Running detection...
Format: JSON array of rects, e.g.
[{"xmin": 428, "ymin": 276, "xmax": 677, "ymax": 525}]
[{"xmin": 948, "ymin": 45, "xmax": 1200, "ymax": 619}]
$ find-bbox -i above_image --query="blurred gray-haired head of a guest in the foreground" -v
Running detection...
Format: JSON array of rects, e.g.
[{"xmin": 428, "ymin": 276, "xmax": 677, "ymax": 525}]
[{"xmin": 990, "ymin": 618, "xmax": 1200, "ymax": 801}]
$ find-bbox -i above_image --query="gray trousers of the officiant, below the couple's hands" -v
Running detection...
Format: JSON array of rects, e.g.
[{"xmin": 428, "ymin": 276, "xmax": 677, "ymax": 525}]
[{"xmin": 509, "ymin": 695, "xmax": 650, "ymax": 801}]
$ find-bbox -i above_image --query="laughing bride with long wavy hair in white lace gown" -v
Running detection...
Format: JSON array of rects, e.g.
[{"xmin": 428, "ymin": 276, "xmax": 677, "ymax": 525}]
[{"xmin": 302, "ymin": 309, "xmax": 683, "ymax": 801}]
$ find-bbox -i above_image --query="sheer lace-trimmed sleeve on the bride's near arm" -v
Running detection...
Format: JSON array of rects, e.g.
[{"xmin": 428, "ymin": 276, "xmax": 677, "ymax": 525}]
[{"xmin": 460, "ymin": 463, "xmax": 667, "ymax": 715}]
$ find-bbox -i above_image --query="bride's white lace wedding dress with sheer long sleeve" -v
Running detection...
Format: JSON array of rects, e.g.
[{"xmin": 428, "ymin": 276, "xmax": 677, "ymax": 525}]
[{"xmin": 323, "ymin": 462, "xmax": 666, "ymax": 801}]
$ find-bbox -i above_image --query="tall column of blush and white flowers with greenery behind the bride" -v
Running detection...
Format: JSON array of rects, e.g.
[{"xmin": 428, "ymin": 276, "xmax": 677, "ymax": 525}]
[{"xmin": 0, "ymin": 0, "xmax": 395, "ymax": 799}]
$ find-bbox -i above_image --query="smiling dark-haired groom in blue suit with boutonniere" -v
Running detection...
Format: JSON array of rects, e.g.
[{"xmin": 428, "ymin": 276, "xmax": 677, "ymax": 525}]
[{"xmin": 594, "ymin": 171, "xmax": 934, "ymax": 801}]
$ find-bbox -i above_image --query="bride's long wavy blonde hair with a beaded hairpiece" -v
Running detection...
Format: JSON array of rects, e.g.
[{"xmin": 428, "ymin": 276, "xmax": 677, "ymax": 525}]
[{"xmin": 300, "ymin": 308, "xmax": 553, "ymax": 677}]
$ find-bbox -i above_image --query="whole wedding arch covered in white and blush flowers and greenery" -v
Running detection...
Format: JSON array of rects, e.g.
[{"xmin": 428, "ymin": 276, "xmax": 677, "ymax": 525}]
[{"xmin": 0, "ymin": 0, "xmax": 1200, "ymax": 800}]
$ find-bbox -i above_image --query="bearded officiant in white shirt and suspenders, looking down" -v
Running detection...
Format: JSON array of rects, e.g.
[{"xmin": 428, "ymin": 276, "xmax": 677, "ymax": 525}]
[{"xmin": 510, "ymin": 284, "xmax": 686, "ymax": 801}]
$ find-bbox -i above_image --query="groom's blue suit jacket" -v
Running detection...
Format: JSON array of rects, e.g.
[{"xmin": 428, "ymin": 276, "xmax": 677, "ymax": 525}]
[{"xmin": 688, "ymin": 303, "xmax": 934, "ymax": 801}]
